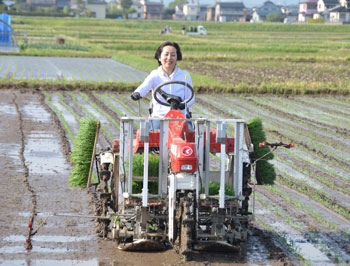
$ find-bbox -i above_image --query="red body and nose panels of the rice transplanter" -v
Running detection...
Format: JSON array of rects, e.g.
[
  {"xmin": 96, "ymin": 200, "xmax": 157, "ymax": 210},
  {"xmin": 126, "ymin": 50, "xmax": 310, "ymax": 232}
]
[{"xmin": 113, "ymin": 110, "xmax": 235, "ymax": 173}]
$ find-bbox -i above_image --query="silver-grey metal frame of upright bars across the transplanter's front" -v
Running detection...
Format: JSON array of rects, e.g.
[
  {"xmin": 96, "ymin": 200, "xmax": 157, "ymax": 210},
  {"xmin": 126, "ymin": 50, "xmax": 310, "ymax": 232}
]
[{"xmin": 119, "ymin": 117, "xmax": 247, "ymax": 208}]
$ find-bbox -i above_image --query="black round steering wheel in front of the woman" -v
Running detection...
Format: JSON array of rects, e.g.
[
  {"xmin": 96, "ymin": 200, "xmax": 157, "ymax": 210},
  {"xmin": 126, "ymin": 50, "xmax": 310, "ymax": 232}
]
[{"xmin": 153, "ymin": 80, "xmax": 194, "ymax": 106}]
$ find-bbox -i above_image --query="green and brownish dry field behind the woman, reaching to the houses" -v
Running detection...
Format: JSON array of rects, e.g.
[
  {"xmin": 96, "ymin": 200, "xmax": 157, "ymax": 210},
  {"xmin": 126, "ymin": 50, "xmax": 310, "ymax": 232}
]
[{"xmin": 4, "ymin": 17, "xmax": 350, "ymax": 94}]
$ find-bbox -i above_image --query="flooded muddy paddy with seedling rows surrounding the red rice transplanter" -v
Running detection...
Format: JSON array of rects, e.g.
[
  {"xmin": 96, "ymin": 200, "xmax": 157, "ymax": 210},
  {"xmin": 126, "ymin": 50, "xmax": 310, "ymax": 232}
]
[{"xmin": 0, "ymin": 87, "xmax": 350, "ymax": 265}]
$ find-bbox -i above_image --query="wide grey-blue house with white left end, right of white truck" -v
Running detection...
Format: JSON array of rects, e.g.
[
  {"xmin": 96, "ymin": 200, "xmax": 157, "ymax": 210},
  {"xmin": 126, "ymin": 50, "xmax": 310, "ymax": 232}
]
[{"xmin": 215, "ymin": 2, "xmax": 245, "ymax": 22}]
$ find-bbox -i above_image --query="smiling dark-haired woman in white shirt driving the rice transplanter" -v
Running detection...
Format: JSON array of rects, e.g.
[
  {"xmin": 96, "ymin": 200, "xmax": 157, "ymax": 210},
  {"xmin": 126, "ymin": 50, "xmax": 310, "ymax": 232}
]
[{"xmin": 131, "ymin": 42, "xmax": 195, "ymax": 129}]
